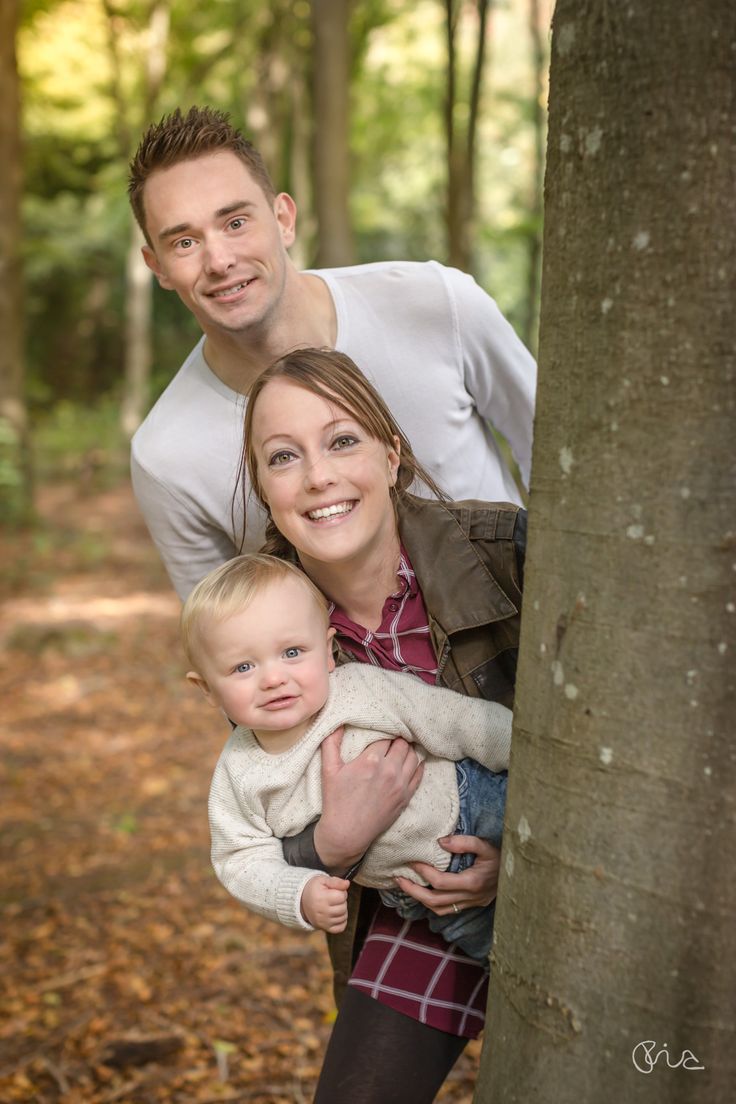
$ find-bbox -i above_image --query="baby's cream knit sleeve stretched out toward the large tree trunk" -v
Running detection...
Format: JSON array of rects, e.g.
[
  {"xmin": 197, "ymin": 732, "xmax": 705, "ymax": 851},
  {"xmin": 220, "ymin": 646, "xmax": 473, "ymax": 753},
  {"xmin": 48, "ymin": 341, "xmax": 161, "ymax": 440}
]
[{"xmin": 339, "ymin": 664, "xmax": 512, "ymax": 771}]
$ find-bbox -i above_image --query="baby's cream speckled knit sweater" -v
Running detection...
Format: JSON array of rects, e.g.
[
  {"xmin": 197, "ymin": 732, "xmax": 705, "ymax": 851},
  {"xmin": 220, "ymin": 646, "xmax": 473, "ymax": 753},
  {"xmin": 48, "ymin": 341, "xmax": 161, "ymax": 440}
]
[{"xmin": 210, "ymin": 662, "xmax": 511, "ymax": 931}]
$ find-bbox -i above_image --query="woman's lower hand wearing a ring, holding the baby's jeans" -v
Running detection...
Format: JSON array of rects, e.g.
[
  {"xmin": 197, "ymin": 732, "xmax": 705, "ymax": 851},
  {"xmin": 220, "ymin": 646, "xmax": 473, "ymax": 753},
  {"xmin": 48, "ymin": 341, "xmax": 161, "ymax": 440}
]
[{"xmin": 396, "ymin": 836, "xmax": 501, "ymax": 916}]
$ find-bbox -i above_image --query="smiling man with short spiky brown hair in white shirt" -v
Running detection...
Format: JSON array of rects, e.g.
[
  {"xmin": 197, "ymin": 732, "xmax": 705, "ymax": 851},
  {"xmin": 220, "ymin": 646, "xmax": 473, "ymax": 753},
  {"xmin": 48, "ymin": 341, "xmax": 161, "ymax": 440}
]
[{"xmin": 129, "ymin": 108, "xmax": 535, "ymax": 598}]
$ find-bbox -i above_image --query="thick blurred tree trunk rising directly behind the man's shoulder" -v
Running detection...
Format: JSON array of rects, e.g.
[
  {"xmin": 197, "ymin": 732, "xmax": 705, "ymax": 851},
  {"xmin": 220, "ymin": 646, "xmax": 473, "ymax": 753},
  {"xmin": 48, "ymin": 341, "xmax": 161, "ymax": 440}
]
[{"xmin": 311, "ymin": 0, "xmax": 355, "ymax": 267}]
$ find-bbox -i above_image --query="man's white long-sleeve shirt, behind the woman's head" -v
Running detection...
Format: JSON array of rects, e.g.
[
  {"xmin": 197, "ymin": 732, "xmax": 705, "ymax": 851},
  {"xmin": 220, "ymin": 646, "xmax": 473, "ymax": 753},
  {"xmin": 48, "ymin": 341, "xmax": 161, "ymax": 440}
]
[{"xmin": 131, "ymin": 261, "xmax": 536, "ymax": 598}]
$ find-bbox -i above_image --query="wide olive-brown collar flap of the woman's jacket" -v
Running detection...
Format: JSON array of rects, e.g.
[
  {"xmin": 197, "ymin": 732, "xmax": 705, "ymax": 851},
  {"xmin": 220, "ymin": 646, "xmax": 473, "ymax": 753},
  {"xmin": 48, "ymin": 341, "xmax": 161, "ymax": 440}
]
[{"xmin": 398, "ymin": 495, "xmax": 518, "ymax": 634}]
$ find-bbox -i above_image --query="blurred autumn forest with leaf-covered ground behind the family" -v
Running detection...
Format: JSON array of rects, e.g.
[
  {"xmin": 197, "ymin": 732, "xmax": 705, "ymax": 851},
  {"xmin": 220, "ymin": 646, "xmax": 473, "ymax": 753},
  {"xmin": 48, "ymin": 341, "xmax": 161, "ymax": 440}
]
[{"xmin": 0, "ymin": 0, "xmax": 552, "ymax": 1104}]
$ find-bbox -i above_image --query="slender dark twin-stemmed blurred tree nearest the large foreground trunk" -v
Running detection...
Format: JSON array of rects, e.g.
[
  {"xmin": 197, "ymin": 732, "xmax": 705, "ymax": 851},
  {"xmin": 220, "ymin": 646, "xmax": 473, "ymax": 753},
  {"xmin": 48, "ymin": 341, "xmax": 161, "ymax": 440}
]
[{"xmin": 444, "ymin": 0, "xmax": 490, "ymax": 272}]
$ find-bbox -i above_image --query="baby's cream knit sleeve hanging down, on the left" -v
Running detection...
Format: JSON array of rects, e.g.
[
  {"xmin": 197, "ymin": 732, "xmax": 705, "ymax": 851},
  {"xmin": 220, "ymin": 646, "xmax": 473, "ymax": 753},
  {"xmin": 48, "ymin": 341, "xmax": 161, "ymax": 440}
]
[{"xmin": 209, "ymin": 746, "xmax": 323, "ymax": 932}]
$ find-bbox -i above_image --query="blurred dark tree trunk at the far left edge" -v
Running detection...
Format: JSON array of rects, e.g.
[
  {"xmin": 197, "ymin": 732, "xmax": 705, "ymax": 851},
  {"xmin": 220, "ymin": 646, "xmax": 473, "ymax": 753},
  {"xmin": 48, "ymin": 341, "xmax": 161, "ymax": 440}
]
[{"xmin": 0, "ymin": 0, "xmax": 33, "ymax": 521}]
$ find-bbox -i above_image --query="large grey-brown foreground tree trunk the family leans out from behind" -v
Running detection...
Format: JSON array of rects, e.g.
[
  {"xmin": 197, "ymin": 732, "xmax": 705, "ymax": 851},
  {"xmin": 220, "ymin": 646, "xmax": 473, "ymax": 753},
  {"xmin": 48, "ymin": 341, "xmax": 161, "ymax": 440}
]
[{"xmin": 476, "ymin": 0, "xmax": 736, "ymax": 1104}]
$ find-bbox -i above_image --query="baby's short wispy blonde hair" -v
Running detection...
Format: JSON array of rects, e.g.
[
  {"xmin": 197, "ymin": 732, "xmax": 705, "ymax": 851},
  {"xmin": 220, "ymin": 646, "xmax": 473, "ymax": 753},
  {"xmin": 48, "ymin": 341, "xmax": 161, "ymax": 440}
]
[{"xmin": 180, "ymin": 552, "xmax": 329, "ymax": 664}]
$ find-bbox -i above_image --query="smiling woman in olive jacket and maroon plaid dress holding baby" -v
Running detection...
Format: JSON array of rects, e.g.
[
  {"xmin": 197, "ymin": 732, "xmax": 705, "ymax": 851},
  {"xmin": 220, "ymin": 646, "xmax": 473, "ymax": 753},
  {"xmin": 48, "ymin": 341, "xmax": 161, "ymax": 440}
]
[{"xmin": 240, "ymin": 349, "xmax": 525, "ymax": 1104}]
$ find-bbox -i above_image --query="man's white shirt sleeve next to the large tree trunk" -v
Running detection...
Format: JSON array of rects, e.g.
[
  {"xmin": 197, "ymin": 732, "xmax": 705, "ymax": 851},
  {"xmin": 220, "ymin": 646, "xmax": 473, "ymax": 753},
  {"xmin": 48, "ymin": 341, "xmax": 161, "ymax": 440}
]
[{"xmin": 442, "ymin": 262, "xmax": 536, "ymax": 489}]
